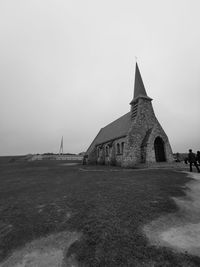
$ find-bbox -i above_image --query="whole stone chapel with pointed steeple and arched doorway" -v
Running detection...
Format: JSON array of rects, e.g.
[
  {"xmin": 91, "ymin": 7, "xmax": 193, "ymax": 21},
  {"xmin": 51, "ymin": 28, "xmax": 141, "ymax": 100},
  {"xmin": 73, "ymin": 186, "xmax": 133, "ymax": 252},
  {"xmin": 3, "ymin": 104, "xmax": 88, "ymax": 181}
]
[{"xmin": 86, "ymin": 63, "xmax": 173, "ymax": 167}]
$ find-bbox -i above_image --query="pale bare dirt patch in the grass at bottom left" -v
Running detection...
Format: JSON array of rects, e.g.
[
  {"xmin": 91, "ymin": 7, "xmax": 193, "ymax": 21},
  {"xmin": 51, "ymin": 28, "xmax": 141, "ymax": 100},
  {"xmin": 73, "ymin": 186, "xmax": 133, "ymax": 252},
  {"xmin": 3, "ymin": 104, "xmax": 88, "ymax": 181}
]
[{"xmin": 0, "ymin": 232, "xmax": 80, "ymax": 267}]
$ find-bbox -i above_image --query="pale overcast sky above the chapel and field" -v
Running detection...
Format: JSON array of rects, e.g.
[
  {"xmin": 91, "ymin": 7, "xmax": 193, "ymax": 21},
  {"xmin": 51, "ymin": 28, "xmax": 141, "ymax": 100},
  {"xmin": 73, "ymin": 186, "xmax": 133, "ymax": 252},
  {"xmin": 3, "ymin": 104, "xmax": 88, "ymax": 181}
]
[{"xmin": 0, "ymin": 0, "xmax": 200, "ymax": 155}]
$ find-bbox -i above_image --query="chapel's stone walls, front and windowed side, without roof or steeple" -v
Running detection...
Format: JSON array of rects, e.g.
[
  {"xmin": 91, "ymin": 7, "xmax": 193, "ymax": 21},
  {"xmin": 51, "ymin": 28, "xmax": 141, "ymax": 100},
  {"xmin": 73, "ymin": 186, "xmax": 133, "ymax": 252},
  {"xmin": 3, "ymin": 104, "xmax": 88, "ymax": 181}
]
[{"xmin": 88, "ymin": 97, "xmax": 173, "ymax": 167}]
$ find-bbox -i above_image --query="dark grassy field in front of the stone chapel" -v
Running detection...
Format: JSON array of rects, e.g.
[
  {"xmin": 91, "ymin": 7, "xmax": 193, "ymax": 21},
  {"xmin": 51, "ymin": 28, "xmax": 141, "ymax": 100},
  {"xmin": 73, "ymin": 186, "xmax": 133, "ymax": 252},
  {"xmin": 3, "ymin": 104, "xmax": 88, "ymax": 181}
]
[{"xmin": 0, "ymin": 158, "xmax": 200, "ymax": 266}]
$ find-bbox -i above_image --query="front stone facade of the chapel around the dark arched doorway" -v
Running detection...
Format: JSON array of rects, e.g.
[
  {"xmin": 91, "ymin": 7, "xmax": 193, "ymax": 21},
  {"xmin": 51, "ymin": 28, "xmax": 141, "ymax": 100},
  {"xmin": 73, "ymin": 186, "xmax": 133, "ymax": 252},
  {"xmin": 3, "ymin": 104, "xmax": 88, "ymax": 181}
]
[{"xmin": 122, "ymin": 98, "xmax": 173, "ymax": 167}]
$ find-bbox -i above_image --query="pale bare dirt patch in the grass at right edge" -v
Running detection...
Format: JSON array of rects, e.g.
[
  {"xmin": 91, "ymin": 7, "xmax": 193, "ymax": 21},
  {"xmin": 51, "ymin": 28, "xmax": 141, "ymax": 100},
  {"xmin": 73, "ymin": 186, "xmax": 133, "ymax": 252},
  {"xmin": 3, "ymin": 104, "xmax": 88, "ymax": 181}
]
[{"xmin": 144, "ymin": 172, "xmax": 200, "ymax": 256}]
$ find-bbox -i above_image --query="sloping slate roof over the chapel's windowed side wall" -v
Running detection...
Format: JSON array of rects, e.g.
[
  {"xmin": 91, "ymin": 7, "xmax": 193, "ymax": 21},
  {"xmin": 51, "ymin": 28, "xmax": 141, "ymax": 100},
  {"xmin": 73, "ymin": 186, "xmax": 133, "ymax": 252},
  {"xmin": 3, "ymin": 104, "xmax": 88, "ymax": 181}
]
[{"xmin": 87, "ymin": 112, "xmax": 131, "ymax": 154}]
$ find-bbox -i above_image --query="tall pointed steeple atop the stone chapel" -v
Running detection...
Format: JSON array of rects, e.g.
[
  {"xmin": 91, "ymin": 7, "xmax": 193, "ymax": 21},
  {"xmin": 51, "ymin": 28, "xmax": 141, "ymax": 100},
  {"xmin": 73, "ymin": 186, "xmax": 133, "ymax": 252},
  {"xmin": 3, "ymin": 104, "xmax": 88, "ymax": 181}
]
[{"xmin": 131, "ymin": 62, "xmax": 152, "ymax": 103}]
